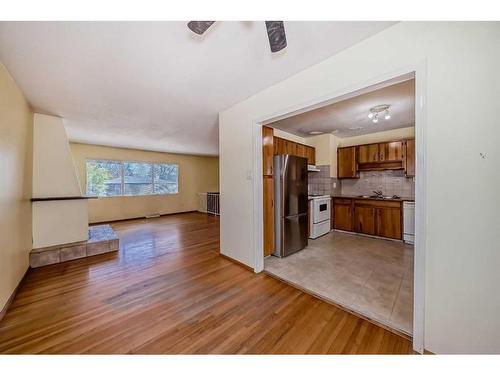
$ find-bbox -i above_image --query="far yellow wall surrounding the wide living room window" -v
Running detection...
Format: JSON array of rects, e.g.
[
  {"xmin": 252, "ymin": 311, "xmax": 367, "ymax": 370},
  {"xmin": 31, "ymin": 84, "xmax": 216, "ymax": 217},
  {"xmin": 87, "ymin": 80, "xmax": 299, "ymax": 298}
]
[{"xmin": 70, "ymin": 143, "xmax": 219, "ymax": 223}]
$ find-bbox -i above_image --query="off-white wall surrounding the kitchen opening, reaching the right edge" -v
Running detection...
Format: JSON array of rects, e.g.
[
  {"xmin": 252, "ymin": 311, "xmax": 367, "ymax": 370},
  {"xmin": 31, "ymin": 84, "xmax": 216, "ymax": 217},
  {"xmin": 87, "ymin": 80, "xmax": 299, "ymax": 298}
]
[{"xmin": 219, "ymin": 22, "xmax": 500, "ymax": 353}]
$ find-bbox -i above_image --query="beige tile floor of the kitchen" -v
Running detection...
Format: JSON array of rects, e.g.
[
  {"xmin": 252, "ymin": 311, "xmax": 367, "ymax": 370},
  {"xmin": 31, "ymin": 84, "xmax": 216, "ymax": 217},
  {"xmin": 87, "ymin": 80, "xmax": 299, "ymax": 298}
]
[{"xmin": 264, "ymin": 231, "xmax": 413, "ymax": 335}]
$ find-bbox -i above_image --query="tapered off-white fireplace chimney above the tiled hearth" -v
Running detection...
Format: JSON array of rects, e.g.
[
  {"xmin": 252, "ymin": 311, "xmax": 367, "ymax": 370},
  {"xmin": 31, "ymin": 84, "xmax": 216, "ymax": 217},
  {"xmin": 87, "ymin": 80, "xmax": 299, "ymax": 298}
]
[{"xmin": 33, "ymin": 113, "xmax": 88, "ymax": 249}]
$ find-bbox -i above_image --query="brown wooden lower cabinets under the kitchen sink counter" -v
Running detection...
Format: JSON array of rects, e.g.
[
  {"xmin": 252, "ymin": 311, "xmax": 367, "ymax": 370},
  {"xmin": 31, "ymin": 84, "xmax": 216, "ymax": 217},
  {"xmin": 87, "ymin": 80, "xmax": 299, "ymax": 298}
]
[{"xmin": 333, "ymin": 198, "xmax": 402, "ymax": 240}]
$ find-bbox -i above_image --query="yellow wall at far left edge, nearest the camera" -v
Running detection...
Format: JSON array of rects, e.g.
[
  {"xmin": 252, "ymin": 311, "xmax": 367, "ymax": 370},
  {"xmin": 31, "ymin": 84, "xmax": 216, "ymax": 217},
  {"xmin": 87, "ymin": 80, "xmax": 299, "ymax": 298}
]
[{"xmin": 0, "ymin": 64, "xmax": 33, "ymax": 310}]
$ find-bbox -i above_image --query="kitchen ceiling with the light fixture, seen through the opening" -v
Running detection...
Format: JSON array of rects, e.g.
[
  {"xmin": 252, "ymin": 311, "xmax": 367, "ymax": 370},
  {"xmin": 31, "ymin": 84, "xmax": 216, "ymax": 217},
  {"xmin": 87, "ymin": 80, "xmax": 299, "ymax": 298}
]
[{"xmin": 270, "ymin": 76, "xmax": 415, "ymax": 138}]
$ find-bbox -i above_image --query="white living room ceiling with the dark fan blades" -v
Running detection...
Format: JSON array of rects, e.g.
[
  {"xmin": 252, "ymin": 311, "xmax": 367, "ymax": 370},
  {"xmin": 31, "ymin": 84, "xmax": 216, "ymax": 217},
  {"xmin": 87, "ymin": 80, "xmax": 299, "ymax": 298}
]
[{"xmin": 0, "ymin": 21, "xmax": 393, "ymax": 155}]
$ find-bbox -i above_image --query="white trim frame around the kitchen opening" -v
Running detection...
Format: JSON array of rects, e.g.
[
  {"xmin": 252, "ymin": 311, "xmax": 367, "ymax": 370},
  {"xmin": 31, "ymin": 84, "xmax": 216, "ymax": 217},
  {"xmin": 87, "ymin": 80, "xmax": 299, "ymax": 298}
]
[{"xmin": 252, "ymin": 60, "xmax": 427, "ymax": 353}]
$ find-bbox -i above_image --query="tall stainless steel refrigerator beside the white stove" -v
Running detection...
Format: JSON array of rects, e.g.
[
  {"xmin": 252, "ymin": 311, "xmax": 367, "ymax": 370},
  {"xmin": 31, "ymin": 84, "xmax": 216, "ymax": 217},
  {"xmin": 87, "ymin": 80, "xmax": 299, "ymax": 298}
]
[{"xmin": 273, "ymin": 155, "xmax": 309, "ymax": 257}]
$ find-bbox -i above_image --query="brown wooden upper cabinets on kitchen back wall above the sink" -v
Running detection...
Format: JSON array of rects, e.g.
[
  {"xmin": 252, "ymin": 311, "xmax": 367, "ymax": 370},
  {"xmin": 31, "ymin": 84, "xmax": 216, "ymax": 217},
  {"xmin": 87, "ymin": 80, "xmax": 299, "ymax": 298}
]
[{"xmin": 337, "ymin": 139, "xmax": 415, "ymax": 178}]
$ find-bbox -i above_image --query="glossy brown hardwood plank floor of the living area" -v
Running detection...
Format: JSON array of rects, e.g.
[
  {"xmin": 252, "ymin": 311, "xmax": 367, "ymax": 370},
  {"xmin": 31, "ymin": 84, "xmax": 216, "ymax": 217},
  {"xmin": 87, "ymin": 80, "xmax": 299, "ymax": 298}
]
[{"xmin": 0, "ymin": 213, "xmax": 412, "ymax": 354}]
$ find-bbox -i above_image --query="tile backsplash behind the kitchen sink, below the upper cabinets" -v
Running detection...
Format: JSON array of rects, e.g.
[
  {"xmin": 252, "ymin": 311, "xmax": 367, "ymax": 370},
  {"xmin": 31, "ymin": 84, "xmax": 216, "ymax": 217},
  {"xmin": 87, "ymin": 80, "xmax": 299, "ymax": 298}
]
[{"xmin": 341, "ymin": 170, "xmax": 415, "ymax": 198}]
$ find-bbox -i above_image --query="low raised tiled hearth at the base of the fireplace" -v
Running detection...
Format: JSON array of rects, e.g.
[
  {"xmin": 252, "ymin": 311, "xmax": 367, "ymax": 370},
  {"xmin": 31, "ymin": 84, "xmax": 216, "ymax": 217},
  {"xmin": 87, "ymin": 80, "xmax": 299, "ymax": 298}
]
[{"xmin": 30, "ymin": 224, "xmax": 120, "ymax": 268}]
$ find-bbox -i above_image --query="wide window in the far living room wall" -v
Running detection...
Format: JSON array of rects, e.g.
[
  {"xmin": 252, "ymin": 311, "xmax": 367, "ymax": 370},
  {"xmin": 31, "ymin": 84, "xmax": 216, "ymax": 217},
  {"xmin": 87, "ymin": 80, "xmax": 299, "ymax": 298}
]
[{"xmin": 87, "ymin": 160, "xmax": 179, "ymax": 197}]
